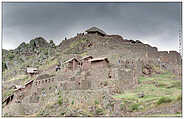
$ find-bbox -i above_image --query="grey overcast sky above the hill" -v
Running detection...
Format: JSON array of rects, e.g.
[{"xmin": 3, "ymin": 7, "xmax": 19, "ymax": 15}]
[{"xmin": 2, "ymin": 2, "xmax": 181, "ymax": 51}]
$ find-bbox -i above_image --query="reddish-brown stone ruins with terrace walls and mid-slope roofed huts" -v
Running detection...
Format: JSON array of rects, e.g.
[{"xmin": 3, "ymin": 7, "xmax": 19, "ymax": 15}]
[{"xmin": 3, "ymin": 27, "xmax": 182, "ymax": 116}]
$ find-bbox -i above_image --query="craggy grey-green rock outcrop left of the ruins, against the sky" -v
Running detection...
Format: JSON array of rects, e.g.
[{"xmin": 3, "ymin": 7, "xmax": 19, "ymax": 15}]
[{"xmin": 2, "ymin": 37, "xmax": 56, "ymax": 80}]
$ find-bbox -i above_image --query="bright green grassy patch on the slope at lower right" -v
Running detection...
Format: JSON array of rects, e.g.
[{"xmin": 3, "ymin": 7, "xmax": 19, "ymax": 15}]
[{"xmin": 113, "ymin": 72, "xmax": 182, "ymax": 111}]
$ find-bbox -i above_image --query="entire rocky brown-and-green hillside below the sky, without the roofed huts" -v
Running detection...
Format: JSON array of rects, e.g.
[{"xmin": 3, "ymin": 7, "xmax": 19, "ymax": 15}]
[{"xmin": 2, "ymin": 27, "xmax": 182, "ymax": 116}]
